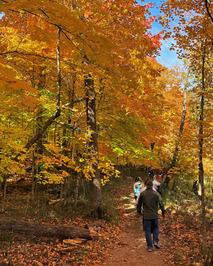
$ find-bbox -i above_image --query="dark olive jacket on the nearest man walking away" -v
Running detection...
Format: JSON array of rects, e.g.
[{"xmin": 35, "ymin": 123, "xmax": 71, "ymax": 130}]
[{"xmin": 137, "ymin": 188, "xmax": 165, "ymax": 219}]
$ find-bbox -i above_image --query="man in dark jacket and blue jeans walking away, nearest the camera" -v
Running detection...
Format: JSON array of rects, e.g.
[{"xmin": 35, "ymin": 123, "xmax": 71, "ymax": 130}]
[{"xmin": 137, "ymin": 180, "xmax": 165, "ymax": 251}]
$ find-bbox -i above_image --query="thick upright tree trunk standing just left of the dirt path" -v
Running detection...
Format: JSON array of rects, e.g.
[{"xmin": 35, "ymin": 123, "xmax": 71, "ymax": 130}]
[{"xmin": 85, "ymin": 75, "xmax": 103, "ymax": 219}]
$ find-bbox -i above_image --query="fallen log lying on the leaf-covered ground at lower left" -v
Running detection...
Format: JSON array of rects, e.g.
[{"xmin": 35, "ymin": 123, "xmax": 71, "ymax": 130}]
[{"xmin": 0, "ymin": 219, "xmax": 91, "ymax": 240}]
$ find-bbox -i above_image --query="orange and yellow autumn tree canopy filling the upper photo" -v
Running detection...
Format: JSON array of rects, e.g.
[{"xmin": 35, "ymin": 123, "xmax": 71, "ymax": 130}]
[{"xmin": 0, "ymin": 0, "xmax": 213, "ymax": 217}]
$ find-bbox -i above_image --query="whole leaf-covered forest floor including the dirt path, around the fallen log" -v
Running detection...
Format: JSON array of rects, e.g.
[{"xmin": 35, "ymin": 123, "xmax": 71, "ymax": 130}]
[{"xmin": 0, "ymin": 179, "xmax": 213, "ymax": 266}]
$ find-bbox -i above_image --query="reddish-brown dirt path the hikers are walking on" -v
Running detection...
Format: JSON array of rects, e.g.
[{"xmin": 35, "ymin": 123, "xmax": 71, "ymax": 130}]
[{"xmin": 103, "ymin": 194, "xmax": 169, "ymax": 266}]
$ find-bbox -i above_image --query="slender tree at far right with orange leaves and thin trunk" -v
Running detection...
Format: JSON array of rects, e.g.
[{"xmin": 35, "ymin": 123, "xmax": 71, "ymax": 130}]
[{"xmin": 162, "ymin": 0, "xmax": 213, "ymax": 235}]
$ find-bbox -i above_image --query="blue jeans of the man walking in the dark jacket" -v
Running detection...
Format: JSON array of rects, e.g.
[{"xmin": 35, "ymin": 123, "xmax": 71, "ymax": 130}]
[{"xmin": 144, "ymin": 219, "xmax": 159, "ymax": 248}]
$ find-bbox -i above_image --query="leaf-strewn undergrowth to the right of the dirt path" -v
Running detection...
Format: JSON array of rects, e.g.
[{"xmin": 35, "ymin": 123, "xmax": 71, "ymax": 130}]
[{"xmin": 162, "ymin": 183, "xmax": 213, "ymax": 266}]
